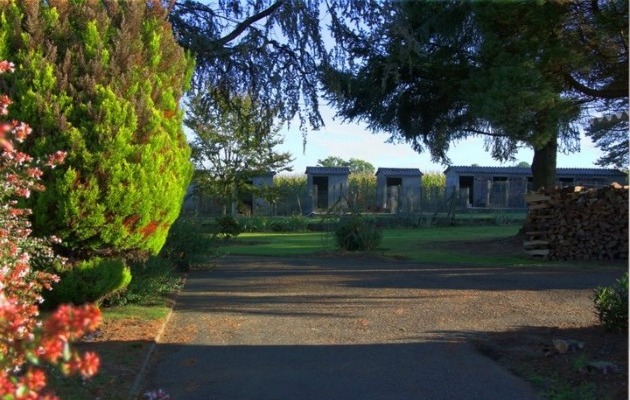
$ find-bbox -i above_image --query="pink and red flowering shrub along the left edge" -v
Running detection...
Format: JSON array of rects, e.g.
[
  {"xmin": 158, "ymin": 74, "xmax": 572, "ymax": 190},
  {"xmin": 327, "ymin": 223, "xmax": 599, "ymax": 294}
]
[{"xmin": 0, "ymin": 61, "xmax": 101, "ymax": 400}]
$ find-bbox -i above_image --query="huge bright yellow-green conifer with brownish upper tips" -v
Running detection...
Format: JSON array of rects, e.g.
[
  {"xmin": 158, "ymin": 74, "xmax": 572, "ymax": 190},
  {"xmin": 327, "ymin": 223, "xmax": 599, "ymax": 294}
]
[{"xmin": 0, "ymin": 0, "xmax": 193, "ymax": 257}]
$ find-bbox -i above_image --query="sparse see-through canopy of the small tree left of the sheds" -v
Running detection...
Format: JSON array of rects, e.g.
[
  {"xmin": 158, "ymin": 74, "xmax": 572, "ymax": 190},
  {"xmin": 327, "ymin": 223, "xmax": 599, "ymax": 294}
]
[{"xmin": 185, "ymin": 89, "xmax": 292, "ymax": 213}]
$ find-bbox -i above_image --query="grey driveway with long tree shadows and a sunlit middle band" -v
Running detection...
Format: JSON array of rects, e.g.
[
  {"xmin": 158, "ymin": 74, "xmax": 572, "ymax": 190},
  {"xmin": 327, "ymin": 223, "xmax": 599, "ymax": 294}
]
[{"xmin": 145, "ymin": 257, "xmax": 618, "ymax": 400}]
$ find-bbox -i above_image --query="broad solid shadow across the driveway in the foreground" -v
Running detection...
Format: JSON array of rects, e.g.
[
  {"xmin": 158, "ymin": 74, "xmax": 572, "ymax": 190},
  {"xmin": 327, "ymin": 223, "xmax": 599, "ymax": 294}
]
[{"xmin": 146, "ymin": 342, "xmax": 537, "ymax": 400}]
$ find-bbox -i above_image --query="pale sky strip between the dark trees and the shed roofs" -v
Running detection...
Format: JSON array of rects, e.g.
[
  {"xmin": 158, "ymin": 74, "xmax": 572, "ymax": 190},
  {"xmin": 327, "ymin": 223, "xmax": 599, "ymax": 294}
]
[{"xmin": 276, "ymin": 106, "xmax": 601, "ymax": 174}]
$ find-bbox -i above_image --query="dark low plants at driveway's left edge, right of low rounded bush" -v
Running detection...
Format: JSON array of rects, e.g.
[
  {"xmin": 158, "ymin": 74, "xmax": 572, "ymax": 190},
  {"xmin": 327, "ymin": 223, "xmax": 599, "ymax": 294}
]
[{"xmin": 104, "ymin": 256, "xmax": 183, "ymax": 306}]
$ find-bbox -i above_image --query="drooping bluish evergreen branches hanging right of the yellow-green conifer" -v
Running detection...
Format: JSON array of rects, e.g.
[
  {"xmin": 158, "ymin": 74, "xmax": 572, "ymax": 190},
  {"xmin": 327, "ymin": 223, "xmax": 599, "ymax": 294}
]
[{"xmin": 169, "ymin": 0, "xmax": 330, "ymax": 132}]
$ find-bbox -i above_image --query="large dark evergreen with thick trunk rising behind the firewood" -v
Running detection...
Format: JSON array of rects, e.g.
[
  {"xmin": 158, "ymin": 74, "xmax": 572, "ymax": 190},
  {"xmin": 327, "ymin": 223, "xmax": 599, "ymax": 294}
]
[{"xmin": 324, "ymin": 1, "xmax": 627, "ymax": 187}]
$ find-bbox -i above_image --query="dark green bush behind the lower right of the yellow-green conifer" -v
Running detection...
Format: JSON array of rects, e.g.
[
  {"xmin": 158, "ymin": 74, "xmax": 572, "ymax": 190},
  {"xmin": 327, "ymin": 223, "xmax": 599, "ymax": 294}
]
[{"xmin": 160, "ymin": 215, "xmax": 215, "ymax": 271}]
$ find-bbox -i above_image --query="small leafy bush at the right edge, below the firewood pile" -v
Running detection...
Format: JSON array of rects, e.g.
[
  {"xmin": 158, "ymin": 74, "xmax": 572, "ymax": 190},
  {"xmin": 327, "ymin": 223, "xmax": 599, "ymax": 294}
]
[{"xmin": 593, "ymin": 272, "xmax": 628, "ymax": 332}]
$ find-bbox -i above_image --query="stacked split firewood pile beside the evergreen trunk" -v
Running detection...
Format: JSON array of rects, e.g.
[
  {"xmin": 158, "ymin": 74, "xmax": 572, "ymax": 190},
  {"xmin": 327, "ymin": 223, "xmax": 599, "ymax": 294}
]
[{"xmin": 523, "ymin": 183, "xmax": 628, "ymax": 260}]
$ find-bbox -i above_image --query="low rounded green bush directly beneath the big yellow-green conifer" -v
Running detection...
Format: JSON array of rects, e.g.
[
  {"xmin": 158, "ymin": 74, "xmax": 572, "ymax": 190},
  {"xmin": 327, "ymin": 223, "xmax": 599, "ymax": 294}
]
[{"xmin": 44, "ymin": 257, "xmax": 131, "ymax": 306}]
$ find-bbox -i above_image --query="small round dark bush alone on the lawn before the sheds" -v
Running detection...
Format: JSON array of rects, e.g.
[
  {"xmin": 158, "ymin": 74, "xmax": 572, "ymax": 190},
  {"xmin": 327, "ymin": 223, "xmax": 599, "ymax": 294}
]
[{"xmin": 335, "ymin": 215, "xmax": 383, "ymax": 251}]
